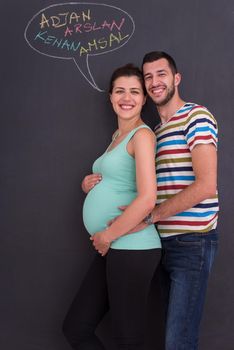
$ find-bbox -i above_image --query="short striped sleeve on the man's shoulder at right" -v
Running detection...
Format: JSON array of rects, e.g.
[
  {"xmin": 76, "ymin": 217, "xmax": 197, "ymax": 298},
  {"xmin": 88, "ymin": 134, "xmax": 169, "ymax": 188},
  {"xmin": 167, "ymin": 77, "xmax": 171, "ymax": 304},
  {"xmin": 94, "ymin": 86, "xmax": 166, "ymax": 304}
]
[{"xmin": 184, "ymin": 106, "xmax": 218, "ymax": 151}]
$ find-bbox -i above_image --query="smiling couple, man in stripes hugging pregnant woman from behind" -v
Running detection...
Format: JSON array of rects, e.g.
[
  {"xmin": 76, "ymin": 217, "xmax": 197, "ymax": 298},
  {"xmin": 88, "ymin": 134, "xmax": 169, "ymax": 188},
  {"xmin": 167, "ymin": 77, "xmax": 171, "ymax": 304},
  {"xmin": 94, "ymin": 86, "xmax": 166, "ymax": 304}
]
[{"xmin": 63, "ymin": 51, "xmax": 218, "ymax": 350}]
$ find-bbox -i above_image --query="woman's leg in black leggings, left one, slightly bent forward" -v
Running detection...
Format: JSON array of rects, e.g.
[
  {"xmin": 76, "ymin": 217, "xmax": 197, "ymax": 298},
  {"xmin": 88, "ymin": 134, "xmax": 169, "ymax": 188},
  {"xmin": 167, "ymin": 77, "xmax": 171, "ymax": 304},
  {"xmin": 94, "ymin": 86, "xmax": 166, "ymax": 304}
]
[{"xmin": 63, "ymin": 255, "xmax": 109, "ymax": 350}]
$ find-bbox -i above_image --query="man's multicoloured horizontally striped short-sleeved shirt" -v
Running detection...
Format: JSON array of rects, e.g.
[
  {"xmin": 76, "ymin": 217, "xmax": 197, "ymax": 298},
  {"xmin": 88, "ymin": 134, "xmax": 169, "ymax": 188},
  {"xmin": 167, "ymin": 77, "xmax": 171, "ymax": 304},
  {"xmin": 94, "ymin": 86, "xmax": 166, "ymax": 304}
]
[{"xmin": 155, "ymin": 103, "xmax": 219, "ymax": 237}]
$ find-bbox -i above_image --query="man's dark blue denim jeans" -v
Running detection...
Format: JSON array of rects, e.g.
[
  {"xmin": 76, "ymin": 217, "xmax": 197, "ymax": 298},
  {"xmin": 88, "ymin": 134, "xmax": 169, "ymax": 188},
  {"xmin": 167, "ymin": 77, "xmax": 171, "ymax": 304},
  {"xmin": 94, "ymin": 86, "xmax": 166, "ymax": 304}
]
[{"xmin": 162, "ymin": 230, "xmax": 218, "ymax": 350}]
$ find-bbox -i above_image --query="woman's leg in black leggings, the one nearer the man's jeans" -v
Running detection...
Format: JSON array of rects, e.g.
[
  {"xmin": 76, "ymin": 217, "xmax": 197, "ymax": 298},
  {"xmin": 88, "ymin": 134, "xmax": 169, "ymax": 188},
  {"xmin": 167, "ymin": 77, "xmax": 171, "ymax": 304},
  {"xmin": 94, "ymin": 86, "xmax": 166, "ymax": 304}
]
[{"xmin": 107, "ymin": 249, "xmax": 161, "ymax": 350}]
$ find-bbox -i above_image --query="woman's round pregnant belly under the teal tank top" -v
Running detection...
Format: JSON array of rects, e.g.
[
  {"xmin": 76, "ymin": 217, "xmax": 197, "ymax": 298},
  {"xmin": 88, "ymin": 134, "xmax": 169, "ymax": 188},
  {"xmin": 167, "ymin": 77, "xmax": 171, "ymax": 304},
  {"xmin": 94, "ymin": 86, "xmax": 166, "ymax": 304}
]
[{"xmin": 83, "ymin": 180, "xmax": 136, "ymax": 235}]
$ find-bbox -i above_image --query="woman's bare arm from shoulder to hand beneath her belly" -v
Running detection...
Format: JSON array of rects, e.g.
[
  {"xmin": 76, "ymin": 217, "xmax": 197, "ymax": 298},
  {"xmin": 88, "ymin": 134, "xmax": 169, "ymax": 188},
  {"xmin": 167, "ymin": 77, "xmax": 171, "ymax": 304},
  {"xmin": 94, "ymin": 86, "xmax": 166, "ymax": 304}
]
[{"xmin": 91, "ymin": 128, "xmax": 157, "ymax": 255}]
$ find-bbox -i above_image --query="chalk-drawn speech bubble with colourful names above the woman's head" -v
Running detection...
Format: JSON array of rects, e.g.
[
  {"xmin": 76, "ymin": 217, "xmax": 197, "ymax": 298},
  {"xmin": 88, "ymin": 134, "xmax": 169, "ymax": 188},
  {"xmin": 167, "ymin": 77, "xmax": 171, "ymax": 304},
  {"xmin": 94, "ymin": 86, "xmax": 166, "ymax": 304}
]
[{"xmin": 24, "ymin": 2, "xmax": 135, "ymax": 91}]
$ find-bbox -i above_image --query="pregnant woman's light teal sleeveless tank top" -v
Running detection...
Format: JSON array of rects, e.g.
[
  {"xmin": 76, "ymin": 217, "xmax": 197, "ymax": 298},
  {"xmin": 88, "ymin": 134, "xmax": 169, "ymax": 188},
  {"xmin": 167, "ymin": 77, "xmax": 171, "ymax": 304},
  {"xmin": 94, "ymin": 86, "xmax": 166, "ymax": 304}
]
[{"xmin": 83, "ymin": 125, "xmax": 161, "ymax": 250}]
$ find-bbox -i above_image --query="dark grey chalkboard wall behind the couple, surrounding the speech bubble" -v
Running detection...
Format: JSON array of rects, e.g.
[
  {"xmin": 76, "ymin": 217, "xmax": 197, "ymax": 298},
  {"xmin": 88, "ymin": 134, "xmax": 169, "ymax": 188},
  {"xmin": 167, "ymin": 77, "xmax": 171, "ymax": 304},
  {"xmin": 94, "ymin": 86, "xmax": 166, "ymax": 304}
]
[{"xmin": 0, "ymin": 0, "xmax": 234, "ymax": 350}]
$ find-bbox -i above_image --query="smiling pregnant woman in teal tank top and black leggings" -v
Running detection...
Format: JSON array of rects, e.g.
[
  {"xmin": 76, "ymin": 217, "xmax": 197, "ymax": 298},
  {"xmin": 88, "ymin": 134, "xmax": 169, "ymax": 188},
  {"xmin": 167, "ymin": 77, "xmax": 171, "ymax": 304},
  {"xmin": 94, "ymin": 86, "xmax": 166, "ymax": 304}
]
[{"xmin": 63, "ymin": 64, "xmax": 161, "ymax": 350}]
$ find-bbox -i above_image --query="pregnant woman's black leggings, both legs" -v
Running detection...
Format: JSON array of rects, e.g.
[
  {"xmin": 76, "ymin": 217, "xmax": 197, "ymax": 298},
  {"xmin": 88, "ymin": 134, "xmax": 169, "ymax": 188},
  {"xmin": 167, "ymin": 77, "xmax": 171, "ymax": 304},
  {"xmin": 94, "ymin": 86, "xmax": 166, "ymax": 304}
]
[{"xmin": 63, "ymin": 249, "xmax": 161, "ymax": 350}]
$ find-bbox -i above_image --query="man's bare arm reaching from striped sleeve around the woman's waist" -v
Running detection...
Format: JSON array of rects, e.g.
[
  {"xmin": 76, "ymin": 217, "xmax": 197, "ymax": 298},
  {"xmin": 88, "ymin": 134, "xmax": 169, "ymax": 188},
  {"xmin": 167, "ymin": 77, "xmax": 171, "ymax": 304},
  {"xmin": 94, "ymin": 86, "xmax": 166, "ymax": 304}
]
[{"xmin": 152, "ymin": 144, "xmax": 217, "ymax": 223}]
